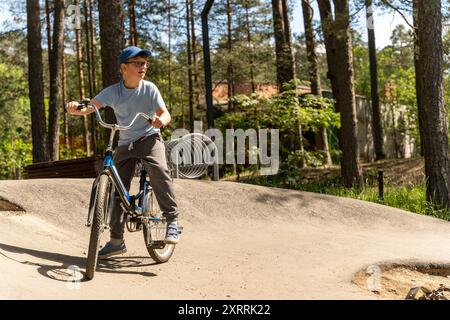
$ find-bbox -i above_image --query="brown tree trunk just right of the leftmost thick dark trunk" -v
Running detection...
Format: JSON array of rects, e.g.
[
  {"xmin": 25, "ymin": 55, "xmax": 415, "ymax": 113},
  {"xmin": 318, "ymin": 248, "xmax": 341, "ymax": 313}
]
[{"xmin": 47, "ymin": 0, "xmax": 65, "ymax": 161}]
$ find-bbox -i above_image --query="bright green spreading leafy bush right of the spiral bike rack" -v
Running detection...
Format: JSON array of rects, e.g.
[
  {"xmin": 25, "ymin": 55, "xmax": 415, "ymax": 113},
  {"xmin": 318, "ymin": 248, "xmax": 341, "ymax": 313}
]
[{"xmin": 215, "ymin": 81, "xmax": 340, "ymax": 177}]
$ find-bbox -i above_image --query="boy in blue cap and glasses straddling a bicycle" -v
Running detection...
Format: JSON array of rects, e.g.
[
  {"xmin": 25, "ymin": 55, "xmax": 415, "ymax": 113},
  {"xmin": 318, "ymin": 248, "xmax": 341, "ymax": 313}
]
[{"xmin": 66, "ymin": 46, "xmax": 179, "ymax": 259}]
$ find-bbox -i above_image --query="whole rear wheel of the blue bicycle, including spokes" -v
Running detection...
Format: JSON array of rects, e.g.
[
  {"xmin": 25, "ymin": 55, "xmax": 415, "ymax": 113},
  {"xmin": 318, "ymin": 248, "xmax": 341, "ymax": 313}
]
[{"xmin": 143, "ymin": 191, "xmax": 175, "ymax": 263}]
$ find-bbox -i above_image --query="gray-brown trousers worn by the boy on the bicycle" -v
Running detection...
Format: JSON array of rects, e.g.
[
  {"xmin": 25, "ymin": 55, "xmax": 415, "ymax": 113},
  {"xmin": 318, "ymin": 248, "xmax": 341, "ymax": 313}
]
[{"xmin": 110, "ymin": 134, "xmax": 178, "ymax": 239}]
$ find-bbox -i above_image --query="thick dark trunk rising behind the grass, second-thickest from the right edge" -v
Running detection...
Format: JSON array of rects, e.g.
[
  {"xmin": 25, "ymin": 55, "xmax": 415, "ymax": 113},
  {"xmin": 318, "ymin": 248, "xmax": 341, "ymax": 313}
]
[{"xmin": 318, "ymin": 0, "xmax": 363, "ymax": 189}]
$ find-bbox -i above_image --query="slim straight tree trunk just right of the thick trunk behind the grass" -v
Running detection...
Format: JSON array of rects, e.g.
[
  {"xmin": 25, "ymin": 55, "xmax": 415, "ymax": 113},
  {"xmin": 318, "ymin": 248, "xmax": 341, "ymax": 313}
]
[{"xmin": 366, "ymin": 0, "xmax": 386, "ymax": 161}]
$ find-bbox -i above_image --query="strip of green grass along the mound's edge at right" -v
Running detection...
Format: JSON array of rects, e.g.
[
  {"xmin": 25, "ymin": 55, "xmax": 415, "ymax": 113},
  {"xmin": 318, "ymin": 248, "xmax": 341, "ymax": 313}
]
[{"xmin": 240, "ymin": 171, "xmax": 450, "ymax": 221}]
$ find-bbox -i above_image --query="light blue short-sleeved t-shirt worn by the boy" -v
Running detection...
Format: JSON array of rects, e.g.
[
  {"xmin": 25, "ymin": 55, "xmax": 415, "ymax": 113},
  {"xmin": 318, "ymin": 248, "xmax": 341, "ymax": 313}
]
[{"xmin": 94, "ymin": 80, "xmax": 165, "ymax": 146}]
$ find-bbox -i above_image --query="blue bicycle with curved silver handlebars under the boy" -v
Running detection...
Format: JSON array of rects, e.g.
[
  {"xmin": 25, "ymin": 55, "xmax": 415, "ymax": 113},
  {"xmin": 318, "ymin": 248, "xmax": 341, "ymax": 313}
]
[{"xmin": 78, "ymin": 100, "xmax": 177, "ymax": 280}]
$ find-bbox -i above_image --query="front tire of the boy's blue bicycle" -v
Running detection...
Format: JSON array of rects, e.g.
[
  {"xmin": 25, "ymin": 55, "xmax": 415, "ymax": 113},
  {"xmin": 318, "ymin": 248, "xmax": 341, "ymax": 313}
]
[{"xmin": 86, "ymin": 174, "xmax": 111, "ymax": 280}]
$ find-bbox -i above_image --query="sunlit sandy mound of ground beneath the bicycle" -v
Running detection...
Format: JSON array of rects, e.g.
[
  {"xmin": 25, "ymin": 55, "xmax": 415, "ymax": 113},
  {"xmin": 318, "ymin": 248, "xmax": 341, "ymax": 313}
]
[{"xmin": 0, "ymin": 179, "xmax": 450, "ymax": 299}]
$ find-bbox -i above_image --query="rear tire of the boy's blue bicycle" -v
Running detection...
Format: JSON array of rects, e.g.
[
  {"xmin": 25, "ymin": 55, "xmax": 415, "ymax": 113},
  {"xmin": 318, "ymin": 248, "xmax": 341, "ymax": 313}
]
[{"xmin": 142, "ymin": 192, "xmax": 175, "ymax": 264}]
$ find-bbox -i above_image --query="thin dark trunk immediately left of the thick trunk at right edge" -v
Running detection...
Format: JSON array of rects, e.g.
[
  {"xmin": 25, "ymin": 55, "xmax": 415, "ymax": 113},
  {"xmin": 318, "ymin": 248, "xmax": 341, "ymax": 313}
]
[{"xmin": 413, "ymin": 0, "xmax": 424, "ymax": 157}]
